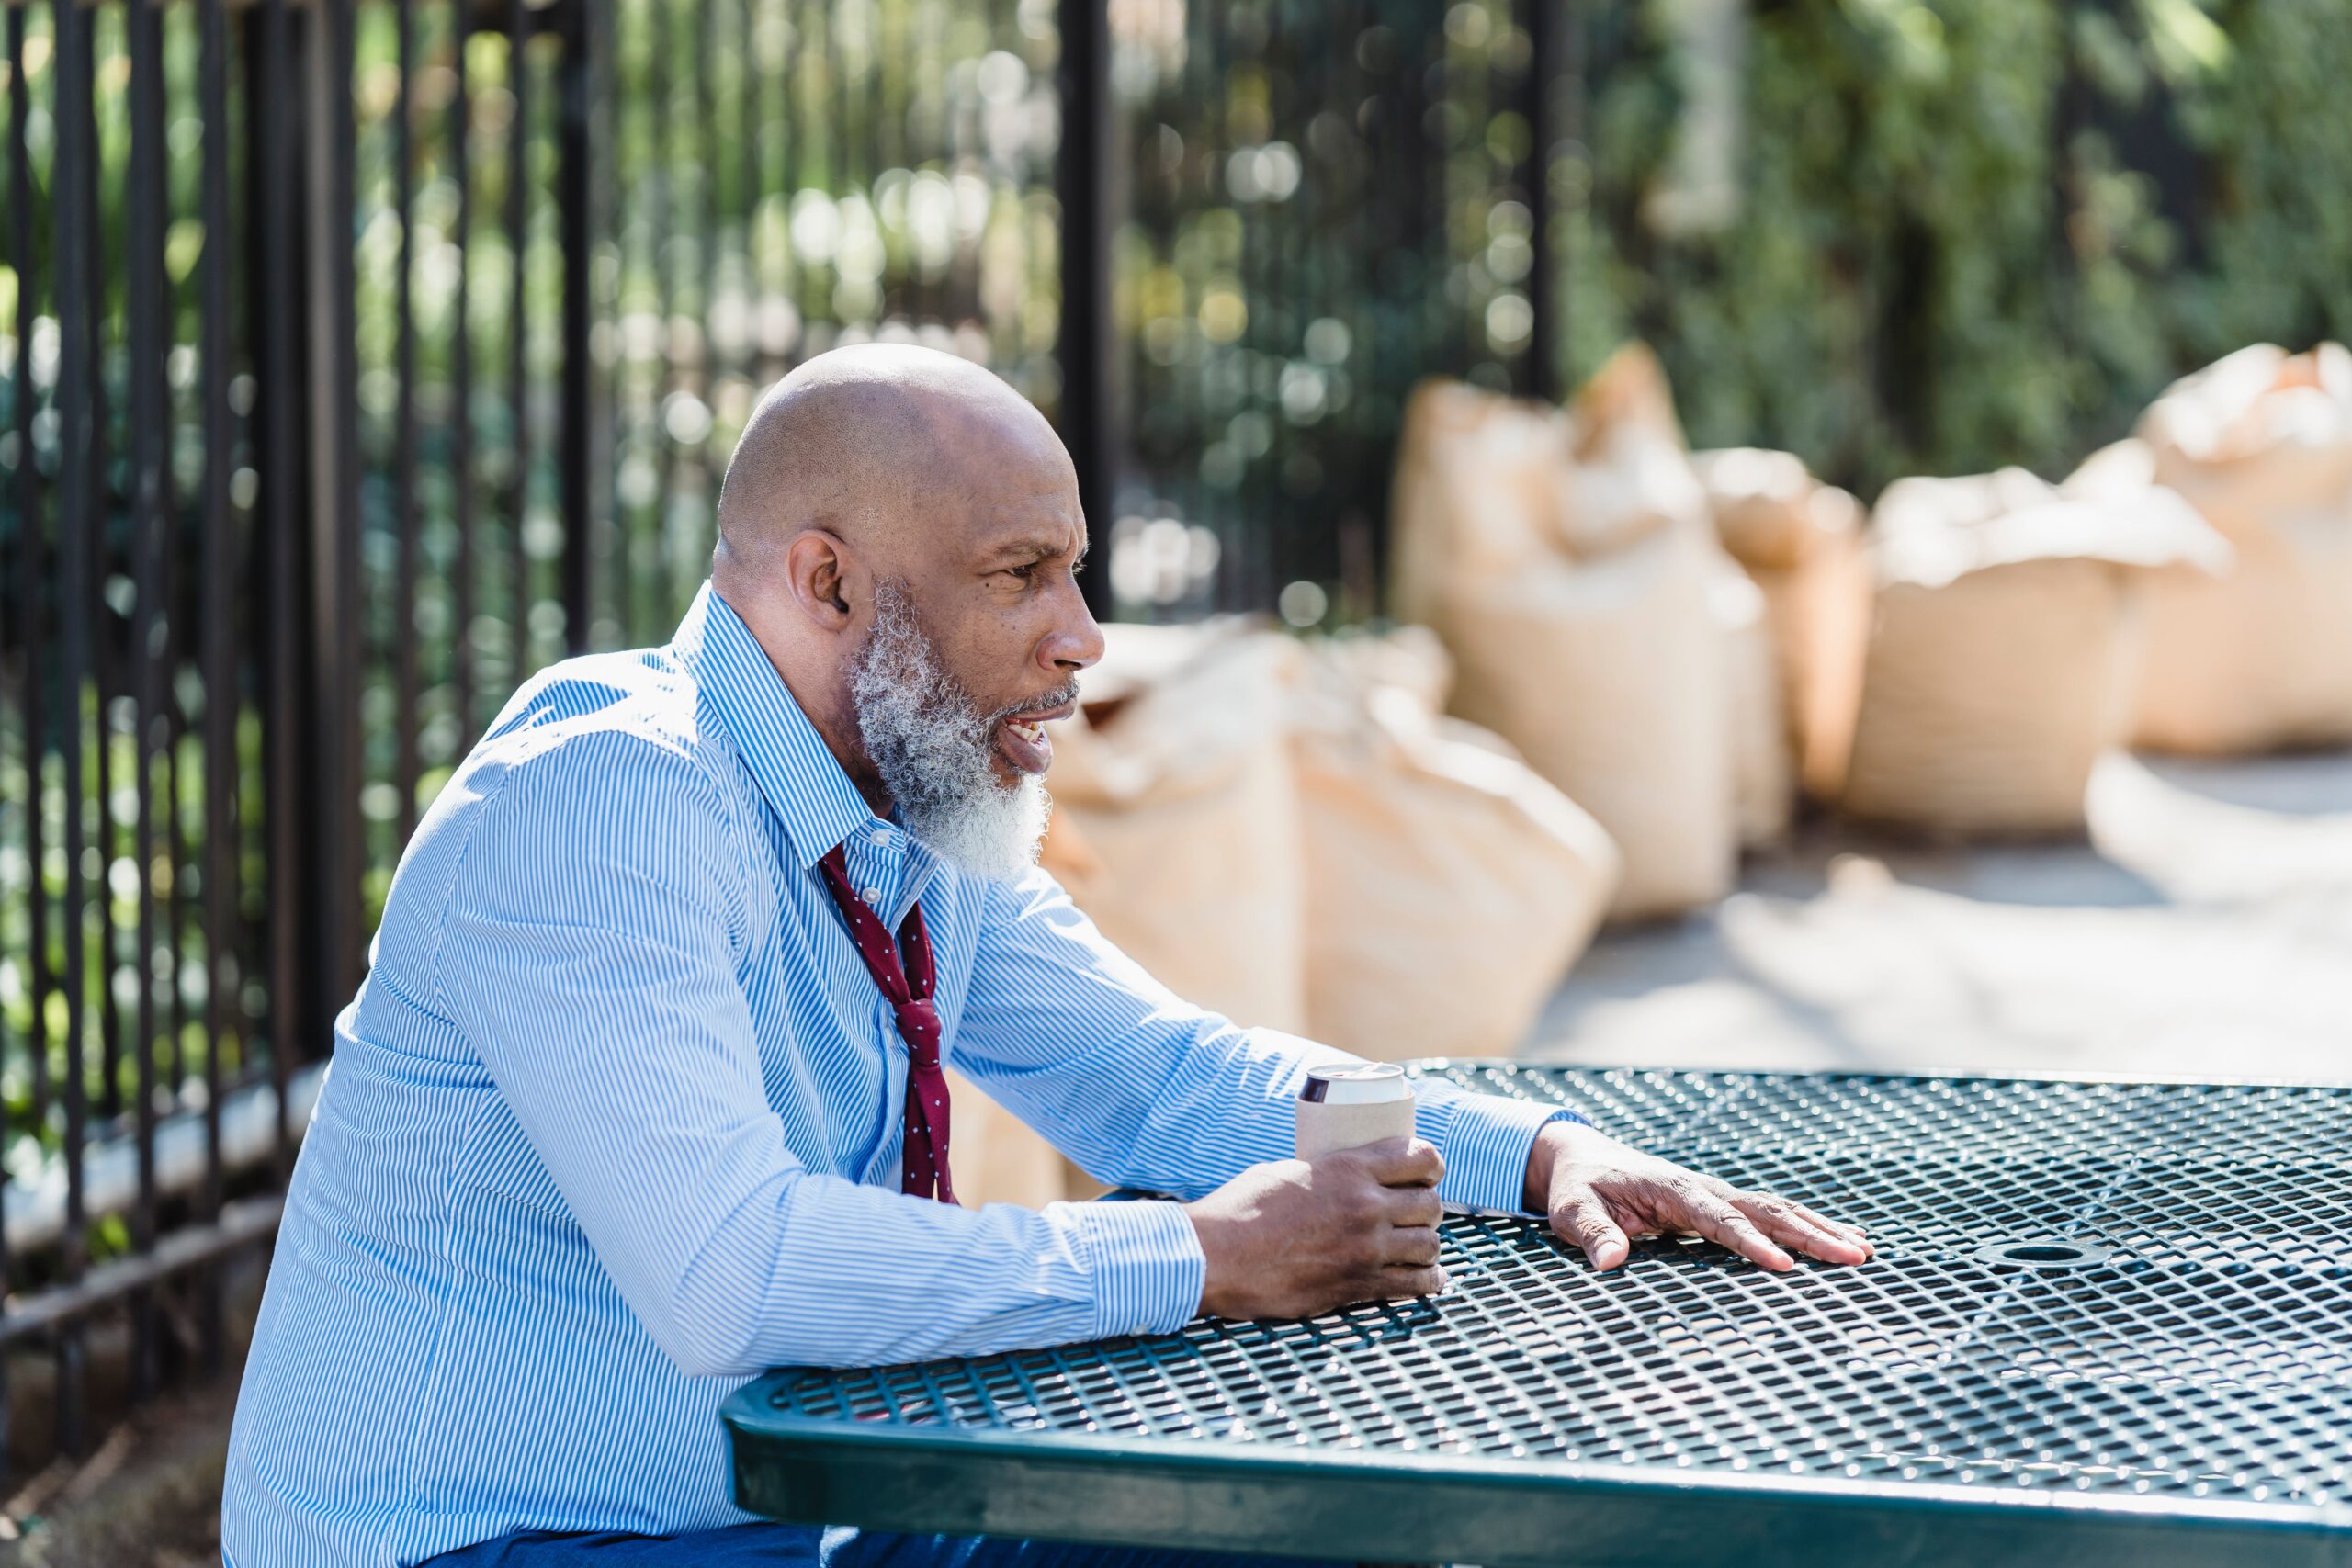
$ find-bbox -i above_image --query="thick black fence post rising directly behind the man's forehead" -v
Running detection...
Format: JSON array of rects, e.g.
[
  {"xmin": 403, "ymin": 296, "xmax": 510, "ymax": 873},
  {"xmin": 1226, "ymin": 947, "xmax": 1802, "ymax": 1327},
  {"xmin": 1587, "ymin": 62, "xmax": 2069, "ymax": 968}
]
[{"xmin": 1054, "ymin": 0, "xmax": 1120, "ymax": 621}]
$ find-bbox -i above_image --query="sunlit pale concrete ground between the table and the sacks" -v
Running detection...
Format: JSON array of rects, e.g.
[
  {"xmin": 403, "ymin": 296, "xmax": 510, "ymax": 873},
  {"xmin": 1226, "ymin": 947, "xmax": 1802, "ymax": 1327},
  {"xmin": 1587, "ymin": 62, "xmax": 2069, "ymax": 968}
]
[{"xmin": 1526, "ymin": 752, "xmax": 2352, "ymax": 1079}]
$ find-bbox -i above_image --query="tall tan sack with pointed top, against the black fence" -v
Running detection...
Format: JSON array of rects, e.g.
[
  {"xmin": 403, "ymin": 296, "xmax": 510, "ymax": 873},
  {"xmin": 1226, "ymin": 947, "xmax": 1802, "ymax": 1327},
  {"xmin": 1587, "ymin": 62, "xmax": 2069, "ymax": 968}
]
[{"xmin": 1395, "ymin": 348, "xmax": 1738, "ymax": 919}]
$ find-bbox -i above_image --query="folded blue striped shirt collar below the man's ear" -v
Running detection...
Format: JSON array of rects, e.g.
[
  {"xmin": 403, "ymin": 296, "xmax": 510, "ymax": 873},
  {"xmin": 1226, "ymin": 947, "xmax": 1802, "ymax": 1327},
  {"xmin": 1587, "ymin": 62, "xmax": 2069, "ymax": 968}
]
[{"xmin": 671, "ymin": 583, "xmax": 882, "ymax": 870}]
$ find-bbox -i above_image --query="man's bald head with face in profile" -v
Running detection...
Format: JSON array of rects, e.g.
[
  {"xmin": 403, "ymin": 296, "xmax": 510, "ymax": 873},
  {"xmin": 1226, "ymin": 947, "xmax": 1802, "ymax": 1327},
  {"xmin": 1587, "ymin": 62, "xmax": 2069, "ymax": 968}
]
[{"xmin": 710, "ymin": 344, "xmax": 1103, "ymax": 837}]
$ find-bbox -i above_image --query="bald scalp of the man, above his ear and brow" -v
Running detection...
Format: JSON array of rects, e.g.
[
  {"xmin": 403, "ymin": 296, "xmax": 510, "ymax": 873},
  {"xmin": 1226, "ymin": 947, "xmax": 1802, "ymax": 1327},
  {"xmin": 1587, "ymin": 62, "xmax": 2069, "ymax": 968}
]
[{"xmin": 715, "ymin": 344, "xmax": 1070, "ymax": 579}]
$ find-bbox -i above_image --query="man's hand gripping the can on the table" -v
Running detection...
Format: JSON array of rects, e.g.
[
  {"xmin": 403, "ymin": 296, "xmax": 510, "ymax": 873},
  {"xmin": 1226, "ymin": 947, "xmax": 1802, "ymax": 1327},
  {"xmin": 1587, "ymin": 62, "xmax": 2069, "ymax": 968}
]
[{"xmin": 1185, "ymin": 1138, "xmax": 1446, "ymax": 1319}]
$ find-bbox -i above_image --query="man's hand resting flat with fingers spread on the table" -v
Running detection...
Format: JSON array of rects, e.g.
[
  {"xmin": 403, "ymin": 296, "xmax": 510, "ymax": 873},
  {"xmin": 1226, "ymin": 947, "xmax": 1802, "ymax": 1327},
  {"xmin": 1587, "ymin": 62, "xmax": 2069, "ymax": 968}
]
[{"xmin": 1526, "ymin": 1122, "xmax": 1870, "ymax": 1272}]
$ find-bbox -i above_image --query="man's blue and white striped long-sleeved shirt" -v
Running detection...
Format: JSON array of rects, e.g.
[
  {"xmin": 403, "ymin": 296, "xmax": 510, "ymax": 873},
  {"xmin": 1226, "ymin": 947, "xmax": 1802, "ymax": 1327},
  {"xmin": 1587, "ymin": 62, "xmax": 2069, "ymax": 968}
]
[{"xmin": 221, "ymin": 585, "xmax": 1580, "ymax": 1568}]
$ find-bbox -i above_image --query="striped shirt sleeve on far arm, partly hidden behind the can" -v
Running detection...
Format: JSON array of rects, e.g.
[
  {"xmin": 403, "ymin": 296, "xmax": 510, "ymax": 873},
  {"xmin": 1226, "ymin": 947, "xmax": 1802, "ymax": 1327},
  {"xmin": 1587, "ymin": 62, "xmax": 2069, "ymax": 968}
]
[{"xmin": 953, "ymin": 870, "xmax": 1583, "ymax": 1211}]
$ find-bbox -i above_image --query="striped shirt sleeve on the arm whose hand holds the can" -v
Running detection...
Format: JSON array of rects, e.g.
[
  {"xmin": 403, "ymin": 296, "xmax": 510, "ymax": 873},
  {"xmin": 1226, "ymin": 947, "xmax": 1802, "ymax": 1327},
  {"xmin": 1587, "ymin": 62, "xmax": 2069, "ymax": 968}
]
[{"xmin": 437, "ymin": 733, "xmax": 1204, "ymax": 1375}]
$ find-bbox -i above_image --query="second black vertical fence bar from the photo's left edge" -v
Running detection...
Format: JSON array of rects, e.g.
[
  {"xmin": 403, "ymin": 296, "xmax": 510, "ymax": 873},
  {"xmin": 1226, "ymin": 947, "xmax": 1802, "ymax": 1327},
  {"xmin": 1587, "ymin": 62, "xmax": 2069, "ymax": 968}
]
[{"xmin": 50, "ymin": 0, "xmax": 96, "ymax": 1453}]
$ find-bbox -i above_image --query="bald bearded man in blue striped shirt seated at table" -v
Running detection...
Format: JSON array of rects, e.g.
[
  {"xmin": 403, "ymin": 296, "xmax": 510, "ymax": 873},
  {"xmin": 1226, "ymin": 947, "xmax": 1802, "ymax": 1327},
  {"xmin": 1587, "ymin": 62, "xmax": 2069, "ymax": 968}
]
[{"xmin": 221, "ymin": 345, "xmax": 1870, "ymax": 1568}]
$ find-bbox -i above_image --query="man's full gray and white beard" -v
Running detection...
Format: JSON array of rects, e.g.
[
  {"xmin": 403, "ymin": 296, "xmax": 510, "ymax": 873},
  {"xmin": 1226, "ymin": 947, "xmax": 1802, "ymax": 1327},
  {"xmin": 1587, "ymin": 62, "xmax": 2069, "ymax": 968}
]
[{"xmin": 849, "ymin": 581, "xmax": 1051, "ymax": 882}]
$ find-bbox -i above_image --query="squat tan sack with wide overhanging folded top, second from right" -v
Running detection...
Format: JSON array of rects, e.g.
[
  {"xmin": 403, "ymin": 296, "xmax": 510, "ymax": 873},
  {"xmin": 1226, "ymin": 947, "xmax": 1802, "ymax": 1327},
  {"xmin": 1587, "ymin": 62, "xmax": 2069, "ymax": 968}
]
[{"xmin": 1841, "ymin": 468, "xmax": 2222, "ymax": 835}]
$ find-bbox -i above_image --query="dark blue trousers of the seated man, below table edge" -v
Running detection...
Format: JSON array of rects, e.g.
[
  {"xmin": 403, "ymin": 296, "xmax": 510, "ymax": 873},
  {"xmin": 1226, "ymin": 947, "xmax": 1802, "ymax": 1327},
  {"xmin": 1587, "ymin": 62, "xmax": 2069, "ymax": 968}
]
[{"xmin": 425, "ymin": 1523, "xmax": 1339, "ymax": 1568}]
